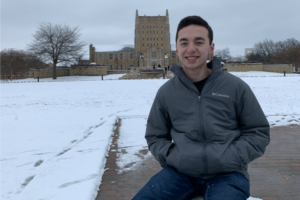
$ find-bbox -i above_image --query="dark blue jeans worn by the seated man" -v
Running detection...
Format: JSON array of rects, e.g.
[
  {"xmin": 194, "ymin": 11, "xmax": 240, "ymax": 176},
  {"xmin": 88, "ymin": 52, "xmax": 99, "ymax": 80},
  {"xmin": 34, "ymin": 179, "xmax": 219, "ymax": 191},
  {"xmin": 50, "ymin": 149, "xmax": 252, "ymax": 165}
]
[{"xmin": 133, "ymin": 166, "xmax": 250, "ymax": 200}]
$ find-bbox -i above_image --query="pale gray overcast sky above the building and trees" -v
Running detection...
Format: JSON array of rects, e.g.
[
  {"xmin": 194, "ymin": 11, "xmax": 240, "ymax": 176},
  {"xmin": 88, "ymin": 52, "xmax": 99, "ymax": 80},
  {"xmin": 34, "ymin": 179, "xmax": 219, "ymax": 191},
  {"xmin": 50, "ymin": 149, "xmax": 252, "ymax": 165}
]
[{"xmin": 0, "ymin": 0, "xmax": 300, "ymax": 58}]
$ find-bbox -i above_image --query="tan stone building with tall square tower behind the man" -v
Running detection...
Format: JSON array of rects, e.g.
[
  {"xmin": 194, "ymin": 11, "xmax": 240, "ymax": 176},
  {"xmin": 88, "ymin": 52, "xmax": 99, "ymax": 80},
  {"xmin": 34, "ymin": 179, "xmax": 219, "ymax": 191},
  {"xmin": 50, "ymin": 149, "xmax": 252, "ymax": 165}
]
[{"xmin": 89, "ymin": 10, "xmax": 211, "ymax": 70}]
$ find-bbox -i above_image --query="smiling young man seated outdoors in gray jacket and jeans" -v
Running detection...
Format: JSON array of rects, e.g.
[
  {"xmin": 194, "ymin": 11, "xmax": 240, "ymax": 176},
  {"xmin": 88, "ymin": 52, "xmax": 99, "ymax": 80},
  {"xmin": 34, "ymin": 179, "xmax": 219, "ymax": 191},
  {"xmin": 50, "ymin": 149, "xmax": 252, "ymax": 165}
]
[{"xmin": 134, "ymin": 16, "xmax": 270, "ymax": 200}]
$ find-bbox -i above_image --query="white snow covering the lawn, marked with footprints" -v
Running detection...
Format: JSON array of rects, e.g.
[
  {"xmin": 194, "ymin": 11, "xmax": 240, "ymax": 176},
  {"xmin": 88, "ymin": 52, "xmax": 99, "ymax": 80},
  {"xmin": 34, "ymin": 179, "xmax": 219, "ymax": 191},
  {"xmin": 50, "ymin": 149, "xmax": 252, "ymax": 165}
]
[{"xmin": 0, "ymin": 72, "xmax": 300, "ymax": 200}]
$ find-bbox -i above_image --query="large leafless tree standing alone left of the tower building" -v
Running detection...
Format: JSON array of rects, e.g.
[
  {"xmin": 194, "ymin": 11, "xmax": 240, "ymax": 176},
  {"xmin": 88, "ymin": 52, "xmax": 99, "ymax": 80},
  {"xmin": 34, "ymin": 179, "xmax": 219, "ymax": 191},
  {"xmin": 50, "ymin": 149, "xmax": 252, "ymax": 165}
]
[{"xmin": 29, "ymin": 22, "xmax": 86, "ymax": 79}]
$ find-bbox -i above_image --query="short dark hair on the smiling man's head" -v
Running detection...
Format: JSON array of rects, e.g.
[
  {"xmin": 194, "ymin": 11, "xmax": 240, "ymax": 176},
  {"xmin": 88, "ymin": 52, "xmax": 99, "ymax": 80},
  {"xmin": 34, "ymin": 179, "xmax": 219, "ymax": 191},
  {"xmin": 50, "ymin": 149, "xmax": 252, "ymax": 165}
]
[{"xmin": 176, "ymin": 16, "xmax": 213, "ymax": 44}]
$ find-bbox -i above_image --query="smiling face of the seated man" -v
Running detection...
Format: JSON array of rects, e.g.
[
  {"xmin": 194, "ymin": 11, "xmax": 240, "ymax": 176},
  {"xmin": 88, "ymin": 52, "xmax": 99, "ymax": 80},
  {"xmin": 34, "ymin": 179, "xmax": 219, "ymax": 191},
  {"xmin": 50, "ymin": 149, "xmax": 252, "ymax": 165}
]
[{"xmin": 176, "ymin": 25, "xmax": 214, "ymax": 70}]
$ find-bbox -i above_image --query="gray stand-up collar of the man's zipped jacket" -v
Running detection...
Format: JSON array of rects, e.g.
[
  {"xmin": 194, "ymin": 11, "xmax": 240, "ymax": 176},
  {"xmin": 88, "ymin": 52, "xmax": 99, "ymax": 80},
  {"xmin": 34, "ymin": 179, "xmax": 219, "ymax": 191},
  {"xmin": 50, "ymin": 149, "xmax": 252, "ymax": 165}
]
[{"xmin": 171, "ymin": 57, "xmax": 222, "ymax": 93}]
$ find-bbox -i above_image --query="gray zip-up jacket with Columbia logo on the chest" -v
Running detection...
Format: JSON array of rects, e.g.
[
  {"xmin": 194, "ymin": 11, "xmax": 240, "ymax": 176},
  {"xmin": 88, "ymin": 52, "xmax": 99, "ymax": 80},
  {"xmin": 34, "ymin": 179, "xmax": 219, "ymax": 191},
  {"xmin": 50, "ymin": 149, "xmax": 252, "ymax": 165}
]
[{"xmin": 145, "ymin": 58, "xmax": 270, "ymax": 179}]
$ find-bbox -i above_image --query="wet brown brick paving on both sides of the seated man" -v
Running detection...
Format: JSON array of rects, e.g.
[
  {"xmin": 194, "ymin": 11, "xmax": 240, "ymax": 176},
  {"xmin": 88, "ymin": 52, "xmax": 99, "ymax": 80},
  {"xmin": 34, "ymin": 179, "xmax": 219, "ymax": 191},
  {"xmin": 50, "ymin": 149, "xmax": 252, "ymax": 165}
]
[{"xmin": 96, "ymin": 123, "xmax": 300, "ymax": 200}]
